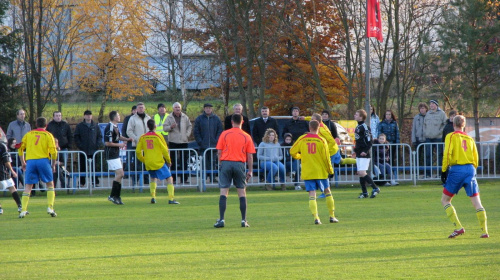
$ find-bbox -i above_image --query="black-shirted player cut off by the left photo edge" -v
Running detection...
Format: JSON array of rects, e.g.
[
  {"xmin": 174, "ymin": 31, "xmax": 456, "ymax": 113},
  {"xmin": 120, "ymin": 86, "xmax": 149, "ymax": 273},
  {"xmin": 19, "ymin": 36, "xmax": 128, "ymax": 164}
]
[{"xmin": 0, "ymin": 142, "xmax": 22, "ymax": 215}]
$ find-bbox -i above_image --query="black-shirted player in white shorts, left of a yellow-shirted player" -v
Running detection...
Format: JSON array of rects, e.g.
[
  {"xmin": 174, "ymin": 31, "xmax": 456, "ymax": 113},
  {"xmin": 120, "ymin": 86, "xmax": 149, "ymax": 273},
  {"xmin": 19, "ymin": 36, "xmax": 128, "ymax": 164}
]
[{"xmin": 104, "ymin": 111, "xmax": 132, "ymax": 205}]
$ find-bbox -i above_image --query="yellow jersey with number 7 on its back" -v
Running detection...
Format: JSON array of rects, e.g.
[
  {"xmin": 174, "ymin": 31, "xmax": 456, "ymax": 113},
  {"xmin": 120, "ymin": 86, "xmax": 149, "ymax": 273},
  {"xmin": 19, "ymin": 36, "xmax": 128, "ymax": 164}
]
[{"xmin": 18, "ymin": 128, "xmax": 57, "ymax": 160}]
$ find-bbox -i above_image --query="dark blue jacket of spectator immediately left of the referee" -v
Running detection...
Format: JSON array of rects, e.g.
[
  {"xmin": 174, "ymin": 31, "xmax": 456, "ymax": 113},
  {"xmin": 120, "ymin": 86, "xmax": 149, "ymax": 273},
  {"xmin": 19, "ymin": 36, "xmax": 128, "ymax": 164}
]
[{"xmin": 193, "ymin": 113, "xmax": 222, "ymax": 151}]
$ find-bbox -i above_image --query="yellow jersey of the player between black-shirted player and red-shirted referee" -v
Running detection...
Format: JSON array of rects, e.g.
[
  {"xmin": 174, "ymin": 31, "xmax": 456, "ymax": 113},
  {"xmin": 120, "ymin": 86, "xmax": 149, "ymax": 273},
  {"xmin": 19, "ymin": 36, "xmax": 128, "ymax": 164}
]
[{"xmin": 135, "ymin": 131, "xmax": 170, "ymax": 170}]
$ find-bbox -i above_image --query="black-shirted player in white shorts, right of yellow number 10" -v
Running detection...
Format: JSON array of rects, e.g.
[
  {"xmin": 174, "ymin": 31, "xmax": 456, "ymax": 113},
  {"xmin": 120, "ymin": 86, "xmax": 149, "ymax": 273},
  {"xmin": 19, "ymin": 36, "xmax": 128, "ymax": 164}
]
[{"xmin": 354, "ymin": 109, "xmax": 380, "ymax": 198}]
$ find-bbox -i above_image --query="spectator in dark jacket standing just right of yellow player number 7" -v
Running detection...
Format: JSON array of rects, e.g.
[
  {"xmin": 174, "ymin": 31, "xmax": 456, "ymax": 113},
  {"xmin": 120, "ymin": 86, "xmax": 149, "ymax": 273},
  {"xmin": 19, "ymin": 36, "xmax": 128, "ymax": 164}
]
[{"xmin": 47, "ymin": 111, "xmax": 73, "ymax": 188}]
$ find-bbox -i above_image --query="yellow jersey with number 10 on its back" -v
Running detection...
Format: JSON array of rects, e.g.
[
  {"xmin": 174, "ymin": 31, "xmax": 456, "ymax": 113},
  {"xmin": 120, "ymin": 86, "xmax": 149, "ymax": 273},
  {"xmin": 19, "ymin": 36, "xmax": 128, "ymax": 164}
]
[{"xmin": 290, "ymin": 133, "xmax": 333, "ymax": 180}]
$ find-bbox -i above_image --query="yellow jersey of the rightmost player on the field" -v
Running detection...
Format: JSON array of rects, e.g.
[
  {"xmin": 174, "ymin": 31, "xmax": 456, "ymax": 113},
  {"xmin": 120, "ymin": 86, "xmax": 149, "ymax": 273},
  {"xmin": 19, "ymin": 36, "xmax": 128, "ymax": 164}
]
[{"xmin": 442, "ymin": 131, "xmax": 479, "ymax": 172}]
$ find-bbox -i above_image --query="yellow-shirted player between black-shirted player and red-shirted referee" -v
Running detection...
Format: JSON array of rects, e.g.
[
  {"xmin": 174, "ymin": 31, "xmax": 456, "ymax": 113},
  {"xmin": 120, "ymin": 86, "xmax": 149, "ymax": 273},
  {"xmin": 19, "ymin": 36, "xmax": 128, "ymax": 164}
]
[{"xmin": 135, "ymin": 120, "xmax": 180, "ymax": 204}]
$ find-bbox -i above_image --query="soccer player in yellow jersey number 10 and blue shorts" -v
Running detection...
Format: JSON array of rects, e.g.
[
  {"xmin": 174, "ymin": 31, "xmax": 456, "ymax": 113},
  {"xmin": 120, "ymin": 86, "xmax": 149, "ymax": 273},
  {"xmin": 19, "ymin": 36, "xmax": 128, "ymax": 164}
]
[{"xmin": 290, "ymin": 120, "xmax": 339, "ymax": 225}]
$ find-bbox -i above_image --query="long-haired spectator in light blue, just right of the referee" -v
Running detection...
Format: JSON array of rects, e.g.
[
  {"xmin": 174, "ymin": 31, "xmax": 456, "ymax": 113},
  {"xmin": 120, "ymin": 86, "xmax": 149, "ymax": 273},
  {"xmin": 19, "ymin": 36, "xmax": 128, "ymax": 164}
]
[{"xmin": 257, "ymin": 128, "xmax": 286, "ymax": 191}]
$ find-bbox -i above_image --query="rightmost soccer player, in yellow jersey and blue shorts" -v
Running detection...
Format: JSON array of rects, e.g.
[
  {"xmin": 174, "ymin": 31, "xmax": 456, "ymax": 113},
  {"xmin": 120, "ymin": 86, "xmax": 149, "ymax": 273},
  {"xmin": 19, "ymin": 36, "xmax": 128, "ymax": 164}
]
[{"xmin": 441, "ymin": 116, "xmax": 490, "ymax": 238}]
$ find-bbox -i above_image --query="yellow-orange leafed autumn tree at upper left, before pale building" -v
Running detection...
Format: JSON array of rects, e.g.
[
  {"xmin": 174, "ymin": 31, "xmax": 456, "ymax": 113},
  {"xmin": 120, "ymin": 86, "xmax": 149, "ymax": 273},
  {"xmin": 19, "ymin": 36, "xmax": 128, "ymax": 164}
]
[{"xmin": 75, "ymin": 0, "xmax": 154, "ymax": 122}]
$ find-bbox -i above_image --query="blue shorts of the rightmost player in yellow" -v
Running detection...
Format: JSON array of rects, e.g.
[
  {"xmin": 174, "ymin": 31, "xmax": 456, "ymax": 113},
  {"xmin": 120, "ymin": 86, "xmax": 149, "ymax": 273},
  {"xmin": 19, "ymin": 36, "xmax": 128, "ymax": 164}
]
[{"xmin": 443, "ymin": 164, "xmax": 479, "ymax": 196}]
